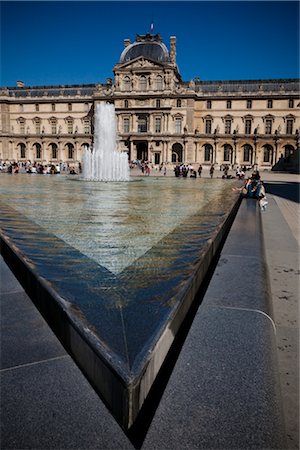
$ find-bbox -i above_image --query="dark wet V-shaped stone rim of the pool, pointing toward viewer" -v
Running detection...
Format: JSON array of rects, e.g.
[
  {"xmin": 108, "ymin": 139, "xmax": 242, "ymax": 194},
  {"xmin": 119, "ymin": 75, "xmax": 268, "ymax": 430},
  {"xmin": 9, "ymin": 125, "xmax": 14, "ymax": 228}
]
[{"xmin": 0, "ymin": 192, "xmax": 240, "ymax": 429}]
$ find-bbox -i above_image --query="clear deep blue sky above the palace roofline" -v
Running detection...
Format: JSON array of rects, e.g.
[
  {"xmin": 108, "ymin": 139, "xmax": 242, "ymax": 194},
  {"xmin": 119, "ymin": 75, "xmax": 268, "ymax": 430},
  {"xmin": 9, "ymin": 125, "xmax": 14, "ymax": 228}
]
[{"xmin": 0, "ymin": 1, "xmax": 299, "ymax": 86}]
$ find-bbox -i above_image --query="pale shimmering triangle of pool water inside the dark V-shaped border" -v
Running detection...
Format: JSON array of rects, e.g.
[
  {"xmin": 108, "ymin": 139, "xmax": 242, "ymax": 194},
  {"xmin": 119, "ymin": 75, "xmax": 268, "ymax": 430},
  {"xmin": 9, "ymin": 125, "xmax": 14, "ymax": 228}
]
[{"xmin": 0, "ymin": 174, "xmax": 236, "ymax": 274}]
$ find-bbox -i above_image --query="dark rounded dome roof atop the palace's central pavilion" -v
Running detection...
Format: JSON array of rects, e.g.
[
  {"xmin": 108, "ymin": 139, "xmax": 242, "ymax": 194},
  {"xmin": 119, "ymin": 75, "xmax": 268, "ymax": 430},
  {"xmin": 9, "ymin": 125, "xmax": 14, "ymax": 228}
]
[{"xmin": 120, "ymin": 34, "xmax": 170, "ymax": 63}]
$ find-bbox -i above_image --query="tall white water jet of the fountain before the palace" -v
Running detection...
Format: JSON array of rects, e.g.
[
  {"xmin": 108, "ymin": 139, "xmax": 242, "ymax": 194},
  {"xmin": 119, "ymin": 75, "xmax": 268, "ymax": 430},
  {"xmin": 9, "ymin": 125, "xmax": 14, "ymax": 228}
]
[{"xmin": 82, "ymin": 103, "xmax": 129, "ymax": 181}]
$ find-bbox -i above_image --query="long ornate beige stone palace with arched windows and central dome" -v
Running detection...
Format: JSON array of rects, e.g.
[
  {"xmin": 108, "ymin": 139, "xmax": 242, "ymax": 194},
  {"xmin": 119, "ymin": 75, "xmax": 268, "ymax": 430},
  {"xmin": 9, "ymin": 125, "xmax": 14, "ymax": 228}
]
[{"xmin": 0, "ymin": 34, "xmax": 300, "ymax": 169}]
